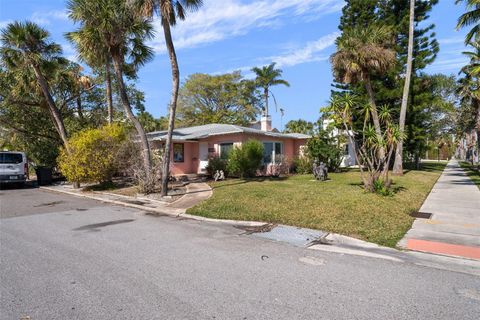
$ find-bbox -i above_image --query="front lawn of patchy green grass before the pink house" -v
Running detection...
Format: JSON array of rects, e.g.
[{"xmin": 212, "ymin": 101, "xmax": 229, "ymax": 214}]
[{"xmin": 187, "ymin": 163, "xmax": 445, "ymax": 247}]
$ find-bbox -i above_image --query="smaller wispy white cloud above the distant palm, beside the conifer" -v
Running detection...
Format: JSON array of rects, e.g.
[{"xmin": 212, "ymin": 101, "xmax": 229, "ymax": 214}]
[{"xmin": 269, "ymin": 32, "xmax": 340, "ymax": 67}]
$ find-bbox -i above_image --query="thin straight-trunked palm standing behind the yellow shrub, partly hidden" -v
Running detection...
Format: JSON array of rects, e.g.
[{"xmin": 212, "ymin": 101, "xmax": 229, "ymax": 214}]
[{"xmin": 65, "ymin": 29, "xmax": 113, "ymax": 124}]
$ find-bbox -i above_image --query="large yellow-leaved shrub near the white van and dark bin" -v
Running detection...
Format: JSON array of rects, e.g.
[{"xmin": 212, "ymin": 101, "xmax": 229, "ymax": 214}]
[{"xmin": 58, "ymin": 124, "xmax": 127, "ymax": 183}]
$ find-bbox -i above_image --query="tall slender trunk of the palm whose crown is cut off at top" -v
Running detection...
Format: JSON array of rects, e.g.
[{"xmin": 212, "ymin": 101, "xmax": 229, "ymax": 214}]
[{"xmin": 162, "ymin": 17, "xmax": 180, "ymax": 196}]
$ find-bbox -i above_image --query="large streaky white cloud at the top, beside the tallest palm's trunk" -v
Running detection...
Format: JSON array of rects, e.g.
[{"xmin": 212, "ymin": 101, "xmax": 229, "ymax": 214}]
[{"xmin": 150, "ymin": 0, "xmax": 344, "ymax": 53}]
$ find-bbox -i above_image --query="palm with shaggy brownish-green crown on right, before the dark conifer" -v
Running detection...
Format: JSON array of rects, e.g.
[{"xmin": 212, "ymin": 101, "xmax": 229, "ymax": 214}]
[{"xmin": 330, "ymin": 26, "xmax": 396, "ymax": 160}]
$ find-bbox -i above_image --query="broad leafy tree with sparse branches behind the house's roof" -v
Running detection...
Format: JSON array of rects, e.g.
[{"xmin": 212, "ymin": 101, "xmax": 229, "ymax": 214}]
[{"xmin": 178, "ymin": 71, "xmax": 260, "ymax": 126}]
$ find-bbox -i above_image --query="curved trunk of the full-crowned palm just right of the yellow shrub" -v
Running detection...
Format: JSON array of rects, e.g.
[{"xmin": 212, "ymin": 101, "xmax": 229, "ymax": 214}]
[{"xmin": 113, "ymin": 57, "xmax": 152, "ymax": 175}]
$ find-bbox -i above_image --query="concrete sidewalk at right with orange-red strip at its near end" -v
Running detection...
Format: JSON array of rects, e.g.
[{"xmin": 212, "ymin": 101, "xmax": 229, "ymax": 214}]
[{"xmin": 398, "ymin": 160, "xmax": 480, "ymax": 259}]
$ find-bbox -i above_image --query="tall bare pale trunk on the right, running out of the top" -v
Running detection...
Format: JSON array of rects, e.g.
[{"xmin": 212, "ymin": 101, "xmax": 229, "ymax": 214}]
[{"xmin": 393, "ymin": 0, "xmax": 415, "ymax": 175}]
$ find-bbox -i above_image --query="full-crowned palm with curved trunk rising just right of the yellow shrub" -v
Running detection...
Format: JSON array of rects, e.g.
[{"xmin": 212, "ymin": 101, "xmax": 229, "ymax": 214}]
[{"xmin": 67, "ymin": 0, "xmax": 153, "ymax": 181}]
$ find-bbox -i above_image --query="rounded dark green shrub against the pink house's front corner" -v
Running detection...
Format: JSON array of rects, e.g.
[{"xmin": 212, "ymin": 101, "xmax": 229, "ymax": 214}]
[{"xmin": 227, "ymin": 139, "xmax": 263, "ymax": 178}]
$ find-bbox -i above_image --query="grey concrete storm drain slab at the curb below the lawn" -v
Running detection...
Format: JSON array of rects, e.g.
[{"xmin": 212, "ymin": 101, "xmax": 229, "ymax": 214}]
[{"xmin": 246, "ymin": 225, "xmax": 328, "ymax": 247}]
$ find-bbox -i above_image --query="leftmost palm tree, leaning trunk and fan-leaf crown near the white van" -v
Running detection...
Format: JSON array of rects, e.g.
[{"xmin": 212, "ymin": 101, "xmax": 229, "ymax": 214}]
[{"xmin": 0, "ymin": 21, "xmax": 70, "ymax": 152}]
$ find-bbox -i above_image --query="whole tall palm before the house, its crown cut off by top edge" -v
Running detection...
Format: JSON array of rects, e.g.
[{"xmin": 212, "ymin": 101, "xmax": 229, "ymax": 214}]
[{"xmin": 129, "ymin": 0, "xmax": 203, "ymax": 196}]
